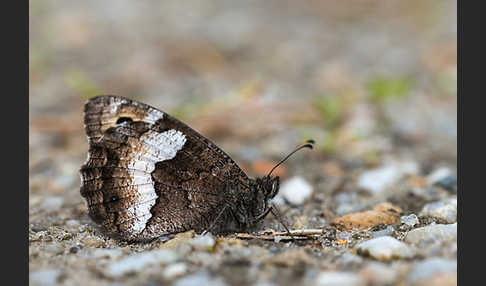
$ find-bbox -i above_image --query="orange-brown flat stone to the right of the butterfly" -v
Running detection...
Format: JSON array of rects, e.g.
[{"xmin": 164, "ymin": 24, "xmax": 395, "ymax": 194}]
[{"xmin": 331, "ymin": 203, "xmax": 402, "ymax": 230}]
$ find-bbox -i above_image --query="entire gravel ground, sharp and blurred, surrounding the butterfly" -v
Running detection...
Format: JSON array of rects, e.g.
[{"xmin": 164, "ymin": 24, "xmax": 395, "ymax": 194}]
[{"xmin": 29, "ymin": 0, "xmax": 457, "ymax": 286}]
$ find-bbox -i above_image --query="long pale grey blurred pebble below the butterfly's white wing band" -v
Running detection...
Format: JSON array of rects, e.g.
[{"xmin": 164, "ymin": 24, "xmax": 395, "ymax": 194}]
[{"xmin": 107, "ymin": 249, "xmax": 179, "ymax": 276}]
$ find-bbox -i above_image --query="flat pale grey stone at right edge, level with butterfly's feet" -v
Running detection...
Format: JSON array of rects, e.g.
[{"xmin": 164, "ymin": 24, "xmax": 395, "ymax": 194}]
[{"xmin": 405, "ymin": 223, "xmax": 457, "ymax": 245}]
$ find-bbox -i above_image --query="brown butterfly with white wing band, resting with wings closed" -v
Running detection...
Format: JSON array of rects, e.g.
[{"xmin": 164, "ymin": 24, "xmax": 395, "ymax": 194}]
[{"xmin": 80, "ymin": 95, "xmax": 314, "ymax": 241}]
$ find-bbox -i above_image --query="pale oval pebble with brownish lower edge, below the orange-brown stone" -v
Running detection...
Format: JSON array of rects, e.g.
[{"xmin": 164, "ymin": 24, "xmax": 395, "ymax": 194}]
[{"xmin": 356, "ymin": 236, "xmax": 415, "ymax": 261}]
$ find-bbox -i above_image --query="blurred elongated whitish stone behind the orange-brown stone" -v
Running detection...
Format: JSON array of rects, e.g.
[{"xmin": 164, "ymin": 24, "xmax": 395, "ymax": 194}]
[{"xmin": 358, "ymin": 162, "xmax": 418, "ymax": 193}]
